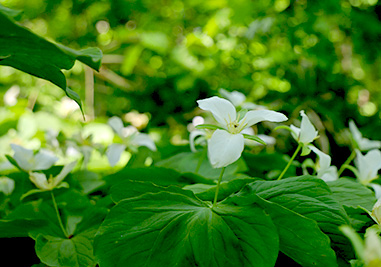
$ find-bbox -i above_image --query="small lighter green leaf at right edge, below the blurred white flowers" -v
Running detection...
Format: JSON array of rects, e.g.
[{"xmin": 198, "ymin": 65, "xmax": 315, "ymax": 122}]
[{"xmin": 327, "ymin": 178, "xmax": 377, "ymax": 211}]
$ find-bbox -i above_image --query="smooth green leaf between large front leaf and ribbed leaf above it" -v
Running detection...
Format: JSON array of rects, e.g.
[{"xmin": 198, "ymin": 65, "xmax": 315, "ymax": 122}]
[{"xmin": 255, "ymin": 196, "xmax": 337, "ymax": 267}]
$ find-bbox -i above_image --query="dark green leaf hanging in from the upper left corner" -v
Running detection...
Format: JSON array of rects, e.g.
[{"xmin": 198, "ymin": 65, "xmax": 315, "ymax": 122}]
[{"xmin": 0, "ymin": 9, "xmax": 102, "ymax": 107}]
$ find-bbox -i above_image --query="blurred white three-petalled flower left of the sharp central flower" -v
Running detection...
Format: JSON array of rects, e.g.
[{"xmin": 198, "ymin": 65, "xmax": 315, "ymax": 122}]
[{"xmin": 106, "ymin": 117, "xmax": 156, "ymax": 166}]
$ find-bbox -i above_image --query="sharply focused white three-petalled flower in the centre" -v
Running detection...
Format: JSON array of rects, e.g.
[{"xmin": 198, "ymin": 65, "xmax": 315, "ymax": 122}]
[{"xmin": 197, "ymin": 96, "xmax": 287, "ymax": 168}]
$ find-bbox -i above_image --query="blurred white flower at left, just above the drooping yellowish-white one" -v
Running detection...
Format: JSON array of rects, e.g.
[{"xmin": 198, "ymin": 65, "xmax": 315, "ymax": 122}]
[{"xmin": 11, "ymin": 144, "xmax": 58, "ymax": 172}]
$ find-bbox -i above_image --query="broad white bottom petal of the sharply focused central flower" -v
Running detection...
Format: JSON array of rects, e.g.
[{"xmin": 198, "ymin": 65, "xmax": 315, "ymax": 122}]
[{"xmin": 208, "ymin": 129, "xmax": 244, "ymax": 168}]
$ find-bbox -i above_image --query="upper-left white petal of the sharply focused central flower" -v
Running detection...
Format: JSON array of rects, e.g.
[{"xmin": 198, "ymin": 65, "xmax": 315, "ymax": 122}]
[{"xmin": 197, "ymin": 96, "xmax": 237, "ymax": 126}]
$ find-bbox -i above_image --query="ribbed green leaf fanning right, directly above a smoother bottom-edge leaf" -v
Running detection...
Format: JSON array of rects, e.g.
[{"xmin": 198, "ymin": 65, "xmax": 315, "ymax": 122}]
[{"xmin": 240, "ymin": 175, "xmax": 349, "ymax": 245}]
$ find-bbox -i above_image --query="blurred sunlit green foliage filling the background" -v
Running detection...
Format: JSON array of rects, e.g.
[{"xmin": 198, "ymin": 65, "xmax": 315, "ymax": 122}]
[{"xmin": 0, "ymin": 0, "xmax": 381, "ymax": 162}]
